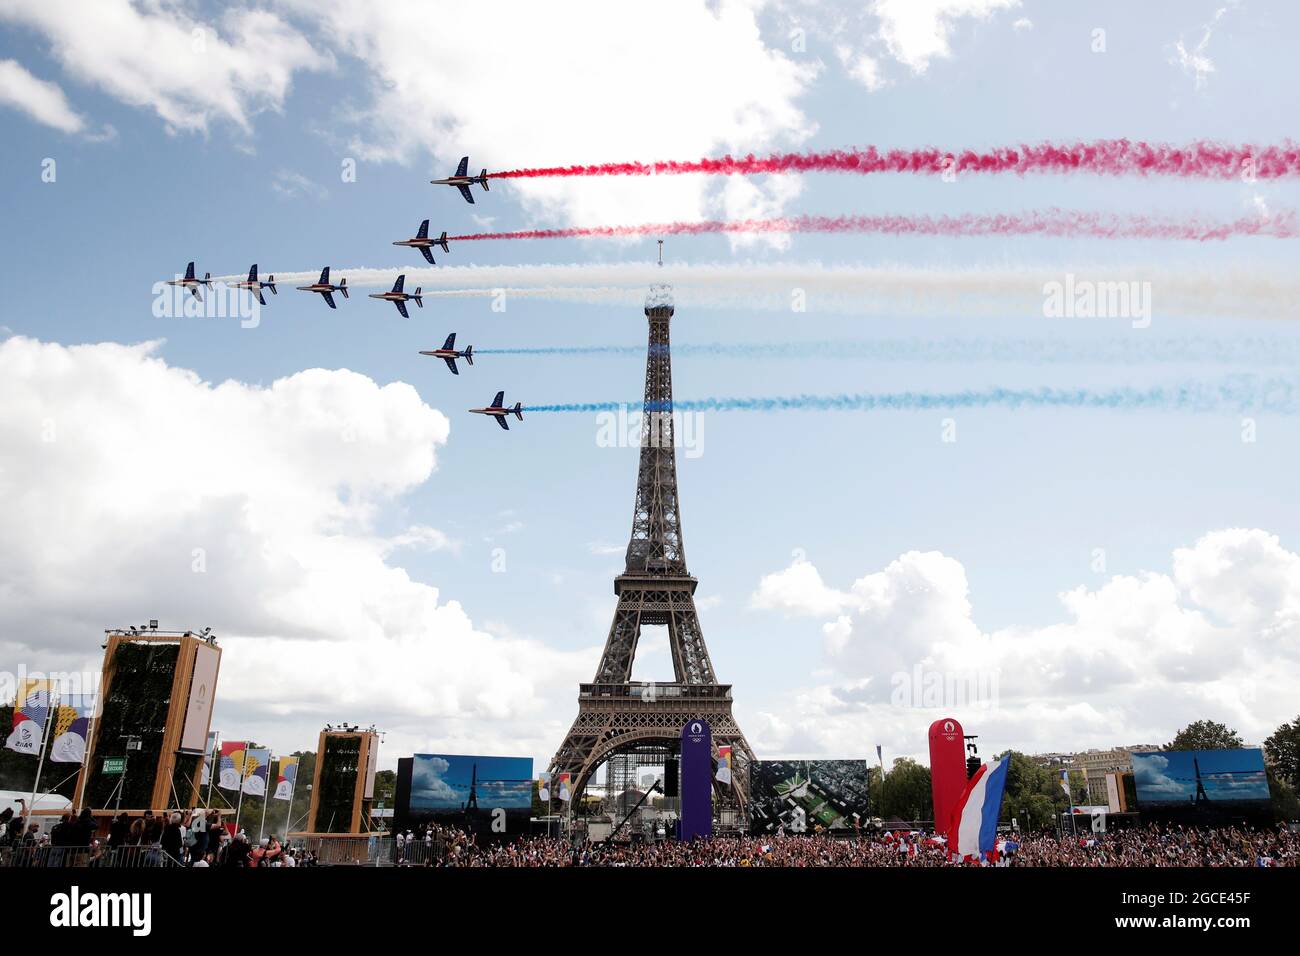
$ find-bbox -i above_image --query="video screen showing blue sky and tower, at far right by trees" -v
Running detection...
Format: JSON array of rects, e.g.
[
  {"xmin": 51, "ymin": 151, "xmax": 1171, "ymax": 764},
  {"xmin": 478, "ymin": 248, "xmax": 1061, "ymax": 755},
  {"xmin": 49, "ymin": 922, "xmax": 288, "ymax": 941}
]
[{"xmin": 1132, "ymin": 748, "xmax": 1270, "ymax": 822}]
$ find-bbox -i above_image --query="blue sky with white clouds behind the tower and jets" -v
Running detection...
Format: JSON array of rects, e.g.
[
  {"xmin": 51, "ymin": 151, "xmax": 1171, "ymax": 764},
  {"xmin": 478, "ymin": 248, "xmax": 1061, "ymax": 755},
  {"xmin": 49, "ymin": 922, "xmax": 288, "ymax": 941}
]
[{"xmin": 0, "ymin": 0, "xmax": 1300, "ymax": 766}]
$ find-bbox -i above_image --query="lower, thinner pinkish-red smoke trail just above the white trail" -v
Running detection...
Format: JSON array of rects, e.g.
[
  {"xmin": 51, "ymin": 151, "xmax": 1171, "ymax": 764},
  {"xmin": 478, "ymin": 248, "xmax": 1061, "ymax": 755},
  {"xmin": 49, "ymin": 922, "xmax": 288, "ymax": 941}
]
[{"xmin": 449, "ymin": 209, "xmax": 1300, "ymax": 242}]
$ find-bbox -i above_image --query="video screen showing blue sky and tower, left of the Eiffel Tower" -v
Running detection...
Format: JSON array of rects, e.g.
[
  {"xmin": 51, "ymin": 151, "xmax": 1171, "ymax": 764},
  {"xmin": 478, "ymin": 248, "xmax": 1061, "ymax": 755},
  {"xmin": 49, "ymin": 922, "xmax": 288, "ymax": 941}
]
[{"xmin": 394, "ymin": 753, "xmax": 533, "ymax": 838}]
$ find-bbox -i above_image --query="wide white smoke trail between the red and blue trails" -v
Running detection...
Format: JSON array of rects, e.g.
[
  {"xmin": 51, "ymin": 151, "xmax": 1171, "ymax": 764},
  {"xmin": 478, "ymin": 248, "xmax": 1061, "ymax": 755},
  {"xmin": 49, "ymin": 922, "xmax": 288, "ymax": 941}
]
[{"xmin": 215, "ymin": 263, "xmax": 1300, "ymax": 319}]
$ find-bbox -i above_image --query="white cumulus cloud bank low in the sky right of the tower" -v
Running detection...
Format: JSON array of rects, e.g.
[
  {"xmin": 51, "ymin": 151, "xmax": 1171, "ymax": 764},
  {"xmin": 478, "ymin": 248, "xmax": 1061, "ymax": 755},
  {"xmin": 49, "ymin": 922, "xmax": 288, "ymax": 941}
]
[{"xmin": 751, "ymin": 528, "xmax": 1300, "ymax": 756}]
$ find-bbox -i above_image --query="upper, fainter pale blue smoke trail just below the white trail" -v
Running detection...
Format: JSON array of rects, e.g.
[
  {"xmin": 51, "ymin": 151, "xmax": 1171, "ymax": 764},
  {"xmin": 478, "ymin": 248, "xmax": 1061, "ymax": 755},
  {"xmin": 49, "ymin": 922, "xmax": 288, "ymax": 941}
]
[{"xmin": 475, "ymin": 336, "xmax": 1300, "ymax": 365}]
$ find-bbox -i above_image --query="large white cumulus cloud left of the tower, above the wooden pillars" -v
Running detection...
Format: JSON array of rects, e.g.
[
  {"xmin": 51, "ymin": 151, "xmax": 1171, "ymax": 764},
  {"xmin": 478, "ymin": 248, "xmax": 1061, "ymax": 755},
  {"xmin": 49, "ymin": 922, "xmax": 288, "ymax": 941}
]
[{"xmin": 0, "ymin": 337, "xmax": 592, "ymax": 754}]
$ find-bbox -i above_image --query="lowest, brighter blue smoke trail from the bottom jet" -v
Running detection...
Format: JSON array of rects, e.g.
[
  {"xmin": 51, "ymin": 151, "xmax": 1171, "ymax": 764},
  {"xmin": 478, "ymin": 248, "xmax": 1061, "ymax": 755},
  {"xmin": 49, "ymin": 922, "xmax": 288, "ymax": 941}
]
[{"xmin": 525, "ymin": 375, "xmax": 1300, "ymax": 415}]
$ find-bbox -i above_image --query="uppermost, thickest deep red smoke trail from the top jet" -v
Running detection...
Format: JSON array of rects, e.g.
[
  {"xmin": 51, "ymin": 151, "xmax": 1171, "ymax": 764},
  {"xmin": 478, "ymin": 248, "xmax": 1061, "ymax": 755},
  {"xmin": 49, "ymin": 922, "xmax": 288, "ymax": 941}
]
[{"xmin": 489, "ymin": 139, "xmax": 1300, "ymax": 179}]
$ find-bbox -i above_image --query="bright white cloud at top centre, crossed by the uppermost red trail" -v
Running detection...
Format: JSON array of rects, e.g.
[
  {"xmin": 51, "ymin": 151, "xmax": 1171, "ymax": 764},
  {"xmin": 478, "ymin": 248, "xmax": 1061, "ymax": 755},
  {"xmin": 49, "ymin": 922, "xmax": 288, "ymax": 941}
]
[{"xmin": 299, "ymin": 0, "xmax": 816, "ymax": 225}]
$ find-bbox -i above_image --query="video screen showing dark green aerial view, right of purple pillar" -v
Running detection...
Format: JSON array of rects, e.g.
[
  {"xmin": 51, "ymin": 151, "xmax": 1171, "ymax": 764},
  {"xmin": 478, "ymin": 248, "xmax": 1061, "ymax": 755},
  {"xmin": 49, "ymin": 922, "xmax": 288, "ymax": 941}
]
[{"xmin": 750, "ymin": 760, "xmax": 870, "ymax": 834}]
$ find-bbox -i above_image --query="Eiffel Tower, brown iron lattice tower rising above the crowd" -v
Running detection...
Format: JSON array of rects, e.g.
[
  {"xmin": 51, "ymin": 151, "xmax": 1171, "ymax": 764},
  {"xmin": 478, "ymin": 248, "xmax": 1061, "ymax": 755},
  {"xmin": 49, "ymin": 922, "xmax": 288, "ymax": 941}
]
[{"xmin": 551, "ymin": 285, "xmax": 754, "ymax": 826}]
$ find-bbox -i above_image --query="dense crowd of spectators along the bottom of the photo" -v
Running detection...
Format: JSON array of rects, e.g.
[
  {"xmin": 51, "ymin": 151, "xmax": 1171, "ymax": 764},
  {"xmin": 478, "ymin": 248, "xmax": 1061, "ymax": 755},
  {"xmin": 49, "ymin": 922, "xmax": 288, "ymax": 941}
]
[{"xmin": 0, "ymin": 806, "xmax": 1300, "ymax": 868}]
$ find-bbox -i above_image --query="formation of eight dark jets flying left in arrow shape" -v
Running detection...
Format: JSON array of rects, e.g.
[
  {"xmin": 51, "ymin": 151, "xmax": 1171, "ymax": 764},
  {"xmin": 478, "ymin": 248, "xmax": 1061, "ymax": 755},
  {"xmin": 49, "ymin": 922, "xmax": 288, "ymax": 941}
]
[{"xmin": 168, "ymin": 150, "xmax": 524, "ymax": 432}]
